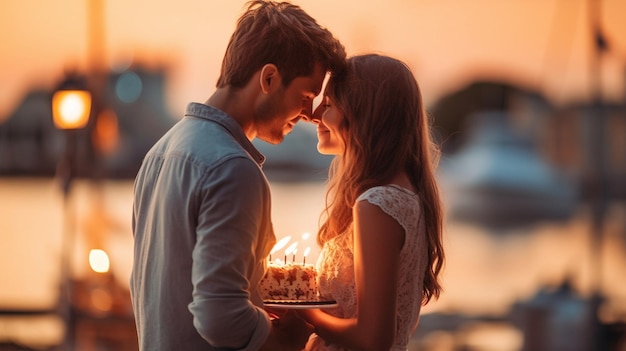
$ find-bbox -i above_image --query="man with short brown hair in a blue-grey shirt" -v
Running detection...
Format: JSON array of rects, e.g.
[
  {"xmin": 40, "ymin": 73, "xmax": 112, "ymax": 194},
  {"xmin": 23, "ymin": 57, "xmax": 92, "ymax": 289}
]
[{"xmin": 130, "ymin": 1, "xmax": 346, "ymax": 351}]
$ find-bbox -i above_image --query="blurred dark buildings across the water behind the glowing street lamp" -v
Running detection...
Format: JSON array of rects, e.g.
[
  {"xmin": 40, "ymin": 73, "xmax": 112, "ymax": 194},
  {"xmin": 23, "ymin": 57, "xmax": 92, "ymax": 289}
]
[{"xmin": 0, "ymin": 66, "xmax": 176, "ymax": 178}]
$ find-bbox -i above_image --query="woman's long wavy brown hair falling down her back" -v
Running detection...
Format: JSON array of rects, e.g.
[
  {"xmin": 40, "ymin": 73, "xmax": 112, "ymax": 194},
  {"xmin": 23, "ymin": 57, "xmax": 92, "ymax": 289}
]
[{"xmin": 318, "ymin": 54, "xmax": 444, "ymax": 304}]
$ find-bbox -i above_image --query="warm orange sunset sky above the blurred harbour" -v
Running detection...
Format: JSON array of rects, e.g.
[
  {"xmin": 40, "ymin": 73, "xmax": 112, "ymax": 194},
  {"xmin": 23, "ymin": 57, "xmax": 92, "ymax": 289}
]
[{"xmin": 0, "ymin": 0, "xmax": 626, "ymax": 120}]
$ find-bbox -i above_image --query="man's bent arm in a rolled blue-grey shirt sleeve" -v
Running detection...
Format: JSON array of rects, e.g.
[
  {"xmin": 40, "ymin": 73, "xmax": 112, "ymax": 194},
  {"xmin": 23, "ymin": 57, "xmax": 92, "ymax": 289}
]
[{"xmin": 189, "ymin": 157, "xmax": 271, "ymax": 350}]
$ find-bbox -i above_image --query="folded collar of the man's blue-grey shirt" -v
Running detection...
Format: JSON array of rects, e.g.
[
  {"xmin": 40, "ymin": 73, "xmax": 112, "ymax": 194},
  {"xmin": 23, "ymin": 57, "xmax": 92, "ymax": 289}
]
[{"xmin": 185, "ymin": 102, "xmax": 265, "ymax": 165}]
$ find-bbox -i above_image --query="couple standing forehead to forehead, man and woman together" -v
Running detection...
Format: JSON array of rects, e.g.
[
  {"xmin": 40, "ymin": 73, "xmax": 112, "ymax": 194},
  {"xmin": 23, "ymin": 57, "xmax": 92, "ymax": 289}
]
[{"xmin": 130, "ymin": 1, "xmax": 444, "ymax": 351}]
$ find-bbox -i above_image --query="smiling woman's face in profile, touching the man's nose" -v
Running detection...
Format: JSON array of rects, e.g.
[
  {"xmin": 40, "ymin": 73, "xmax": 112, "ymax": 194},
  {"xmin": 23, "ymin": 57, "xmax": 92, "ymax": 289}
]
[{"xmin": 313, "ymin": 95, "xmax": 345, "ymax": 155}]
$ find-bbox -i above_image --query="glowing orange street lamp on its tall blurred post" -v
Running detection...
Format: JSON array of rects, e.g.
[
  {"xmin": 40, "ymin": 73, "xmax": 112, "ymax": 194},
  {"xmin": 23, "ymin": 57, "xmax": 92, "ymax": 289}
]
[{"xmin": 52, "ymin": 75, "xmax": 91, "ymax": 351}]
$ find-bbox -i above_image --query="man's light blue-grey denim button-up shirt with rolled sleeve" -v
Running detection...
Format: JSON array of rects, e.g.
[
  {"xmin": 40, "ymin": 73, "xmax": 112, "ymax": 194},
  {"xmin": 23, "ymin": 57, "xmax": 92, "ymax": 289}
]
[{"xmin": 130, "ymin": 103, "xmax": 276, "ymax": 351}]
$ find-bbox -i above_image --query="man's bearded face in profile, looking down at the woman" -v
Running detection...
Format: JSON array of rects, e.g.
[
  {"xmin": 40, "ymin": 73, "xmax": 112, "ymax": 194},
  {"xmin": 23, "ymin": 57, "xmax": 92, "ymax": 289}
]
[{"xmin": 255, "ymin": 64, "xmax": 326, "ymax": 144}]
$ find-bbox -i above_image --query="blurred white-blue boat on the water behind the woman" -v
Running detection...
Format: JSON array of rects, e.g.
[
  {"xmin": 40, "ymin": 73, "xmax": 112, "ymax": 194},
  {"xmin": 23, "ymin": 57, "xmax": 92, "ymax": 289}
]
[{"xmin": 440, "ymin": 112, "xmax": 578, "ymax": 228}]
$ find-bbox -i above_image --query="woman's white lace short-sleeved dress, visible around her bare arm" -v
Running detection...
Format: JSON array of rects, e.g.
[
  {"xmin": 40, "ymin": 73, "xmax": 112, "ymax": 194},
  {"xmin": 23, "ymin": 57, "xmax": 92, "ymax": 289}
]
[{"xmin": 306, "ymin": 185, "xmax": 428, "ymax": 351}]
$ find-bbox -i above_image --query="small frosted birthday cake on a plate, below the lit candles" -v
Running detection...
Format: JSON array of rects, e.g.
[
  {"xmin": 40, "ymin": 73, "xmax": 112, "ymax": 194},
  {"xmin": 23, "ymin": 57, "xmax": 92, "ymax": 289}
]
[{"xmin": 259, "ymin": 263, "xmax": 318, "ymax": 301}]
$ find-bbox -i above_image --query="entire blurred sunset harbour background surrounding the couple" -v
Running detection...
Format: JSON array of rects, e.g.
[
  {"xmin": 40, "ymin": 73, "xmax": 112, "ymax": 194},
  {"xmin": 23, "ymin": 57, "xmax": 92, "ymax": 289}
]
[{"xmin": 0, "ymin": 0, "xmax": 626, "ymax": 351}]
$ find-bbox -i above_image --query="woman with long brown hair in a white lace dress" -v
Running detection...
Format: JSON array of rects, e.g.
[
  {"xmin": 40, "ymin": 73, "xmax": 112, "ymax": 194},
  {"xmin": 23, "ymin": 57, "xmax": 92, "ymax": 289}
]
[{"xmin": 300, "ymin": 54, "xmax": 444, "ymax": 351}]
